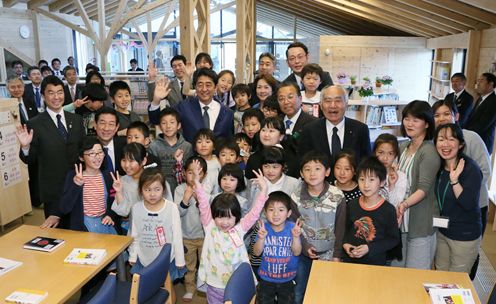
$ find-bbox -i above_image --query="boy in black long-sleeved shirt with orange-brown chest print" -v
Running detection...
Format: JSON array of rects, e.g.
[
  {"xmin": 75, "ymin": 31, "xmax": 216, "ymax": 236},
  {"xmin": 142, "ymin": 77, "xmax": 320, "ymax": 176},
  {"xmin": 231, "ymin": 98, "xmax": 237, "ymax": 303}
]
[{"xmin": 342, "ymin": 156, "xmax": 400, "ymax": 265}]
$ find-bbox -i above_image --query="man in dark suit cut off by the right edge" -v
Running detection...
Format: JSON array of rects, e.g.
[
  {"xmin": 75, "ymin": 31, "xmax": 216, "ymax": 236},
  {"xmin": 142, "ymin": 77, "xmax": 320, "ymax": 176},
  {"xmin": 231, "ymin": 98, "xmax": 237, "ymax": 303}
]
[{"xmin": 465, "ymin": 73, "xmax": 496, "ymax": 154}]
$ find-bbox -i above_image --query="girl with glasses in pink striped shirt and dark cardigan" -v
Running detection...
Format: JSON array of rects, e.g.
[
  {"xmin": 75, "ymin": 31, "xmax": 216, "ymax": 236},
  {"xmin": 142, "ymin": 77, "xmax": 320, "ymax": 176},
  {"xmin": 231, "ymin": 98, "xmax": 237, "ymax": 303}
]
[{"xmin": 60, "ymin": 137, "xmax": 119, "ymax": 234}]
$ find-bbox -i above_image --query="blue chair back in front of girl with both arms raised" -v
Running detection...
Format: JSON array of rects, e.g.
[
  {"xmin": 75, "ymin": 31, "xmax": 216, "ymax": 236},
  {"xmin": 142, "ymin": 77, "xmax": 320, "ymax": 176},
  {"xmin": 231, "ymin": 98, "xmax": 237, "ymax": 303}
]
[{"xmin": 224, "ymin": 263, "xmax": 256, "ymax": 304}]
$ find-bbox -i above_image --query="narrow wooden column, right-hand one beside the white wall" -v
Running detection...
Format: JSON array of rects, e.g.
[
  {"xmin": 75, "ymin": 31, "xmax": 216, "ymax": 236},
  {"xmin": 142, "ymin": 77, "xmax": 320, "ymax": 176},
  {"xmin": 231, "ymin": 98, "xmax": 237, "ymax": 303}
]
[{"xmin": 236, "ymin": 0, "xmax": 257, "ymax": 83}]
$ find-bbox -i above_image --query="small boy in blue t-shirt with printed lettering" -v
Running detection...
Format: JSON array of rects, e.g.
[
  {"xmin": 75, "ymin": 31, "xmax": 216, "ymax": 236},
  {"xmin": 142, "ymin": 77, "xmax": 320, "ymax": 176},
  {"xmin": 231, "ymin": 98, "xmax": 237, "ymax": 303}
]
[{"xmin": 253, "ymin": 191, "xmax": 302, "ymax": 304}]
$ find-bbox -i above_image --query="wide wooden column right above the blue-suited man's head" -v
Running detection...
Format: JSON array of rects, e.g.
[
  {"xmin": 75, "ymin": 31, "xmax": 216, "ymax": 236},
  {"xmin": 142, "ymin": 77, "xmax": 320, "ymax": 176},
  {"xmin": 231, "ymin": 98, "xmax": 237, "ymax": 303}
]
[{"xmin": 179, "ymin": 0, "xmax": 210, "ymax": 61}]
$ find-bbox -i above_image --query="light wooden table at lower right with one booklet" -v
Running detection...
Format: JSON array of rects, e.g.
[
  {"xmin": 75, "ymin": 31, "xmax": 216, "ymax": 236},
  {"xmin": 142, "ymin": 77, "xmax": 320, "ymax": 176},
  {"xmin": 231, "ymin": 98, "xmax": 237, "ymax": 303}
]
[{"xmin": 304, "ymin": 261, "xmax": 480, "ymax": 304}]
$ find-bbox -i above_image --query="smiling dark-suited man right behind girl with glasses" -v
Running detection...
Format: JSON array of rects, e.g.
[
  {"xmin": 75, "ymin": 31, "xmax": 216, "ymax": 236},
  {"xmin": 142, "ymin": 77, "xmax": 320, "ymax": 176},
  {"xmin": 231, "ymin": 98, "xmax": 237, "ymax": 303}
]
[{"xmin": 95, "ymin": 107, "xmax": 126, "ymax": 175}]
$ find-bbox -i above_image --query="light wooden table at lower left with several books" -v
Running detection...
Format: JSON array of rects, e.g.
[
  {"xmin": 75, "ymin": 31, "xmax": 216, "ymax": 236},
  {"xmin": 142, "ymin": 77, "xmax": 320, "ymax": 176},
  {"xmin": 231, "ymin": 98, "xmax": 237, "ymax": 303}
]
[{"xmin": 0, "ymin": 225, "xmax": 132, "ymax": 303}]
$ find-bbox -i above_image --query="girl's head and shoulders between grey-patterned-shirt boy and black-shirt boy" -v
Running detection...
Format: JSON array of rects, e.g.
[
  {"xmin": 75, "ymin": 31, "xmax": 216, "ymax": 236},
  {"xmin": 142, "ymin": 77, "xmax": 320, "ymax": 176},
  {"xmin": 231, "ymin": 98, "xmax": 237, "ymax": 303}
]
[{"xmin": 334, "ymin": 150, "xmax": 362, "ymax": 202}]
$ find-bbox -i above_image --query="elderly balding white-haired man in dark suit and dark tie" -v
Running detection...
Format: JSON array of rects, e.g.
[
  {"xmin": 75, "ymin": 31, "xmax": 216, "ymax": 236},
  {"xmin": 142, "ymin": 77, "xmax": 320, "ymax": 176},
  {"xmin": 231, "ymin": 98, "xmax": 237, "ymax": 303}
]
[{"xmin": 299, "ymin": 86, "xmax": 371, "ymax": 171}]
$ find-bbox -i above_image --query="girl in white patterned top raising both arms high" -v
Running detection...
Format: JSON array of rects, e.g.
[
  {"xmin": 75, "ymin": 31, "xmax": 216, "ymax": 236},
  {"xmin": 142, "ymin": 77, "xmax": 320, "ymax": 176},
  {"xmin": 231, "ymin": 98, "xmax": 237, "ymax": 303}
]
[{"xmin": 195, "ymin": 162, "xmax": 267, "ymax": 304}]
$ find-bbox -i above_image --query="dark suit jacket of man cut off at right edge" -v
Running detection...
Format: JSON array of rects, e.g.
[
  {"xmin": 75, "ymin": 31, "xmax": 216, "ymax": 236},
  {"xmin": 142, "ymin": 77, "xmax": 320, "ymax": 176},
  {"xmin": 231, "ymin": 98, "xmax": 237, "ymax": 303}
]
[{"xmin": 465, "ymin": 92, "xmax": 496, "ymax": 154}]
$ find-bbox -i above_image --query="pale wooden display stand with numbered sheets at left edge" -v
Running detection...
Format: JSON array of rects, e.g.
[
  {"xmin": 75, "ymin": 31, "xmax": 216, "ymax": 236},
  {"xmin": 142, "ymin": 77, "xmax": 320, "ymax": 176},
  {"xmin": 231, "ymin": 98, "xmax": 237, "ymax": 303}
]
[{"xmin": 0, "ymin": 98, "xmax": 32, "ymax": 230}]
